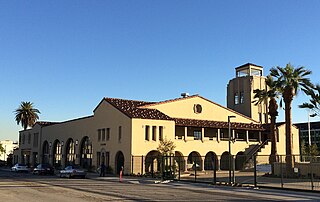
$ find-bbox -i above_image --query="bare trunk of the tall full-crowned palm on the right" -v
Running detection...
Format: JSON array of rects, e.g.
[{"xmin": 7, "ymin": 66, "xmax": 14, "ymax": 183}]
[{"xmin": 283, "ymin": 86, "xmax": 294, "ymax": 176}]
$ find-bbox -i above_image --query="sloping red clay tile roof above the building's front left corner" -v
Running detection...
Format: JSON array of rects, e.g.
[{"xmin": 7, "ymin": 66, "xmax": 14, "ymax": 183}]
[{"xmin": 105, "ymin": 98, "xmax": 172, "ymax": 120}]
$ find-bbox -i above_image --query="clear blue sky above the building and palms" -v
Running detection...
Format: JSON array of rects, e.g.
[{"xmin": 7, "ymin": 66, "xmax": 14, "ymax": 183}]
[{"xmin": 0, "ymin": 0, "xmax": 320, "ymax": 140}]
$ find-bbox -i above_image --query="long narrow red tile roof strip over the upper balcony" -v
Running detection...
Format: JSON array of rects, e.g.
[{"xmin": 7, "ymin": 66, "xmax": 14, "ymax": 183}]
[{"xmin": 174, "ymin": 118, "xmax": 265, "ymax": 131}]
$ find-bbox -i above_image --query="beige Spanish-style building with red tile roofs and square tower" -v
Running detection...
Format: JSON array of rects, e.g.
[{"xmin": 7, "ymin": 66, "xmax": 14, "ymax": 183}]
[{"xmin": 16, "ymin": 63, "xmax": 300, "ymax": 174}]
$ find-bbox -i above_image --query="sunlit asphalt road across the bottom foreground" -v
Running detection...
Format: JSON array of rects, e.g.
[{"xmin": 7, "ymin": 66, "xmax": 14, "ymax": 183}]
[{"xmin": 0, "ymin": 170, "xmax": 320, "ymax": 202}]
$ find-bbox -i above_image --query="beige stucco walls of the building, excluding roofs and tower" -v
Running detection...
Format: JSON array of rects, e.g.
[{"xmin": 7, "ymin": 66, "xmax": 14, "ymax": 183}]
[{"xmin": 13, "ymin": 96, "xmax": 299, "ymax": 173}]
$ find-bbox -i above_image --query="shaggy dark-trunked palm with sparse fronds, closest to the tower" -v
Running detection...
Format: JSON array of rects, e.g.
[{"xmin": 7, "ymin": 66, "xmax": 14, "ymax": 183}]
[{"xmin": 253, "ymin": 75, "xmax": 280, "ymax": 173}]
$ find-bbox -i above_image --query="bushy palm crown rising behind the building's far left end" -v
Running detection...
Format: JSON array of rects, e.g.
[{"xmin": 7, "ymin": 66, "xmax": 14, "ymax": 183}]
[{"xmin": 14, "ymin": 102, "xmax": 40, "ymax": 130}]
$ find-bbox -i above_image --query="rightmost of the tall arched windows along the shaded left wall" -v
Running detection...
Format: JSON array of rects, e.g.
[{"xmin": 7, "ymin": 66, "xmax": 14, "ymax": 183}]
[{"xmin": 80, "ymin": 136, "xmax": 92, "ymax": 169}]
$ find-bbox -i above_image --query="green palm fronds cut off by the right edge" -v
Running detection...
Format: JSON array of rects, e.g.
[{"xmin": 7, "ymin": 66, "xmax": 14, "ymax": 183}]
[{"xmin": 299, "ymin": 85, "xmax": 320, "ymax": 116}]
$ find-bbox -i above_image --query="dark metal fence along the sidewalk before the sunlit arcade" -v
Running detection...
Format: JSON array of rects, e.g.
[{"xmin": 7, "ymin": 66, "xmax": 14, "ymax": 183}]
[{"xmin": 131, "ymin": 155, "xmax": 320, "ymax": 191}]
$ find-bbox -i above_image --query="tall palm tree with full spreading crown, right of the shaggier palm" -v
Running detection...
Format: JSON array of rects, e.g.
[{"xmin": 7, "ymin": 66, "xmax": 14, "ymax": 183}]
[{"xmin": 270, "ymin": 63, "xmax": 314, "ymax": 176}]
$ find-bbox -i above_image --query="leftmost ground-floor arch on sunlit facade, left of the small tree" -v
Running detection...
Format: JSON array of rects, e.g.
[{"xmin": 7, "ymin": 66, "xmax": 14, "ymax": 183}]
[{"xmin": 145, "ymin": 150, "xmax": 162, "ymax": 177}]
